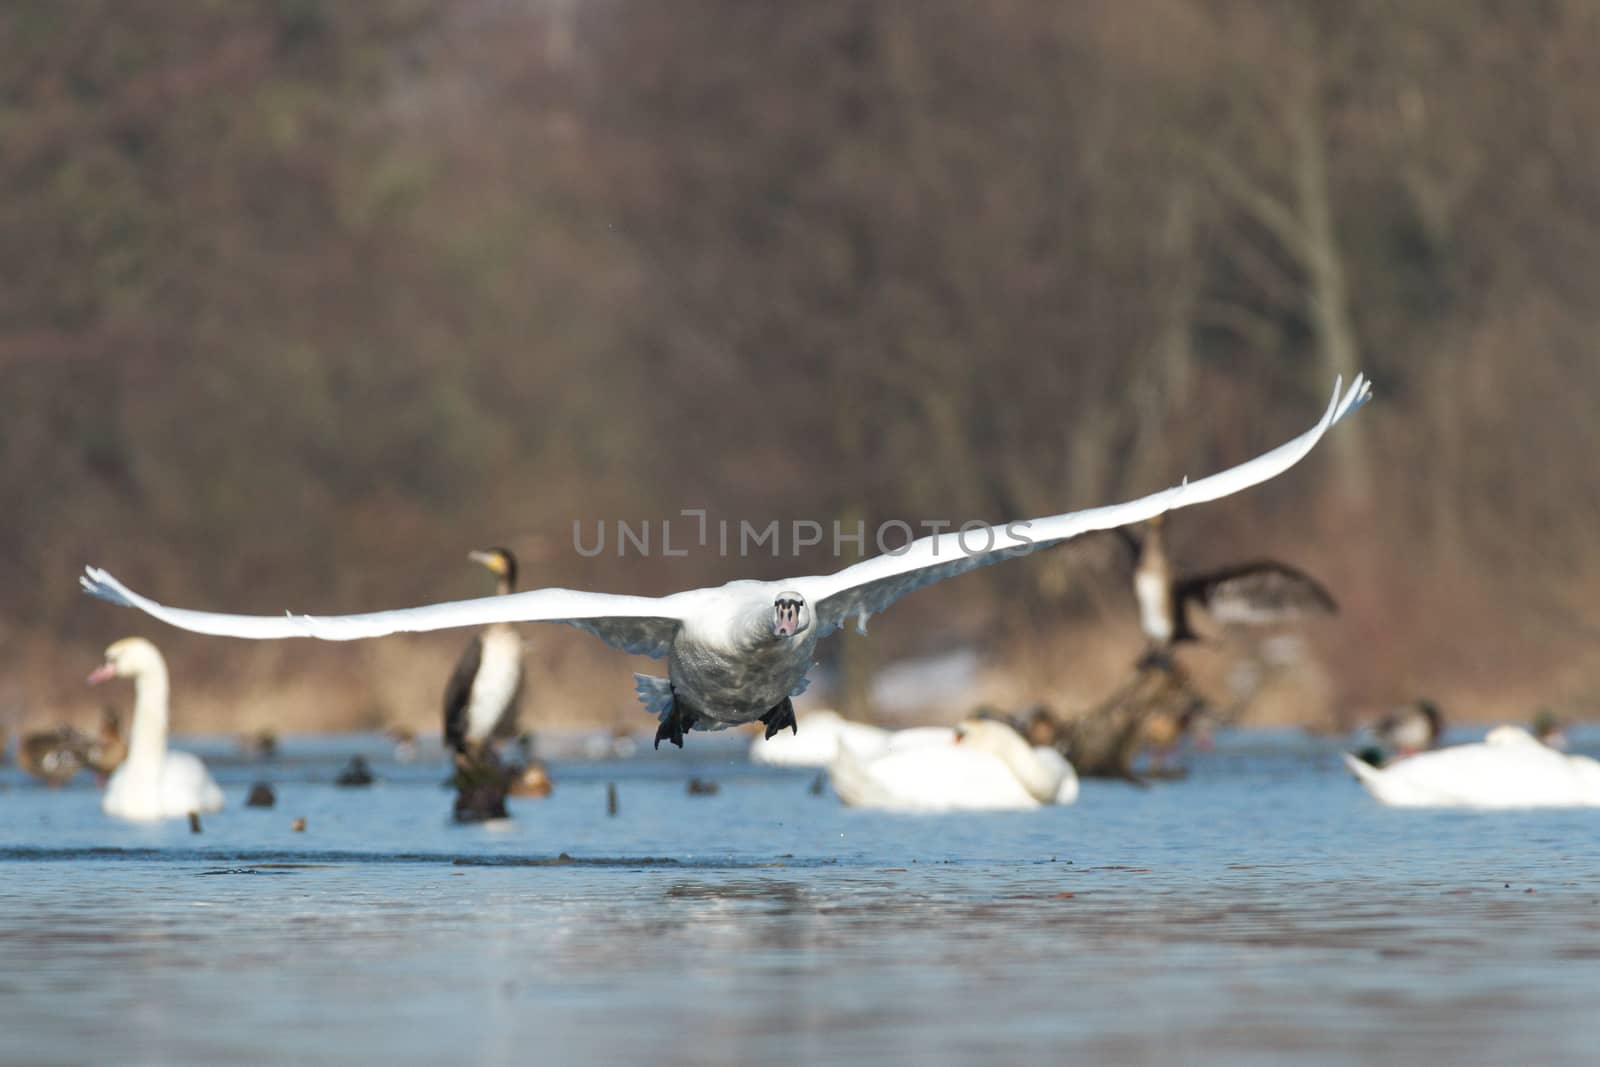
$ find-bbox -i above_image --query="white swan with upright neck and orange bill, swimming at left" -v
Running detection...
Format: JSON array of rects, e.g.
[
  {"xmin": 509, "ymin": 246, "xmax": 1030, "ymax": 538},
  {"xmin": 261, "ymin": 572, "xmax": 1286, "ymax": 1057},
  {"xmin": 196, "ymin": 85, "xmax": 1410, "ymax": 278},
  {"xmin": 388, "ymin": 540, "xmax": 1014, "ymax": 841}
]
[{"xmin": 90, "ymin": 637, "xmax": 222, "ymax": 819}]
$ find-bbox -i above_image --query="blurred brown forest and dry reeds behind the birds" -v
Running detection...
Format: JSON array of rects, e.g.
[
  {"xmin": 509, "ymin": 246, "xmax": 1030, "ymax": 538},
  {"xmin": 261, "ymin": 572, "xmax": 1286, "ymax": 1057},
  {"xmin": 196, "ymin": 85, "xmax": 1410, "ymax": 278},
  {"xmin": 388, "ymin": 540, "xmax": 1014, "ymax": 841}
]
[{"xmin": 0, "ymin": 0, "xmax": 1600, "ymax": 729}]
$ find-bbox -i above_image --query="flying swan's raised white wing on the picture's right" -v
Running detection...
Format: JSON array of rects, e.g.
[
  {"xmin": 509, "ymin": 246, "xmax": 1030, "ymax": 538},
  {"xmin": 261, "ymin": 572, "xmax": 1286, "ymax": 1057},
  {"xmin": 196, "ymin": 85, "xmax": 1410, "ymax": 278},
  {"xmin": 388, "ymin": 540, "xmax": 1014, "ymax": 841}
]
[{"xmin": 787, "ymin": 374, "xmax": 1371, "ymax": 637}]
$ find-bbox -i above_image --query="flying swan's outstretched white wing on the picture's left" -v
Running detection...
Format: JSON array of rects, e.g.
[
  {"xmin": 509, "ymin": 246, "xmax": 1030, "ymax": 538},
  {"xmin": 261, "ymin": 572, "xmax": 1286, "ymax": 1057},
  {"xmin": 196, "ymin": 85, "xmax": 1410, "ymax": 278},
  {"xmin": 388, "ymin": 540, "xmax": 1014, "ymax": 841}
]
[{"xmin": 78, "ymin": 566, "xmax": 686, "ymax": 659}]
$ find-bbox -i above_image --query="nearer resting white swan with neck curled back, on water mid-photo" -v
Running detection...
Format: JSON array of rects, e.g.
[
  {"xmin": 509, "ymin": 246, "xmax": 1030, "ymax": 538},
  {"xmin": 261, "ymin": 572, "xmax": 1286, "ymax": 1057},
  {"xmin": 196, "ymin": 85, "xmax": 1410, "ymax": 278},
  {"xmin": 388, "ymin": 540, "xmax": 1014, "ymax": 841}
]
[{"xmin": 829, "ymin": 718, "xmax": 1078, "ymax": 811}]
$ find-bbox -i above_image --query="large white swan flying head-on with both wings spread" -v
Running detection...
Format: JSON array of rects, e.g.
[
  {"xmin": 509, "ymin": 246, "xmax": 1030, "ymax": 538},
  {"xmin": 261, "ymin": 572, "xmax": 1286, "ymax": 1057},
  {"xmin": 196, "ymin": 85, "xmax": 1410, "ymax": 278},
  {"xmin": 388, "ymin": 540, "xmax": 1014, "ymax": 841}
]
[{"xmin": 82, "ymin": 374, "xmax": 1371, "ymax": 745}]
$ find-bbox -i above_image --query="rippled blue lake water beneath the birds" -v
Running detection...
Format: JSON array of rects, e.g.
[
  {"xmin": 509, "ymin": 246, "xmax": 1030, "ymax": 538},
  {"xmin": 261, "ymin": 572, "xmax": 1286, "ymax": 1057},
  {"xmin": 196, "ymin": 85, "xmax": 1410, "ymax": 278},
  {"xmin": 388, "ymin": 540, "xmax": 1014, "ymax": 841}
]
[{"xmin": 0, "ymin": 731, "xmax": 1600, "ymax": 1064}]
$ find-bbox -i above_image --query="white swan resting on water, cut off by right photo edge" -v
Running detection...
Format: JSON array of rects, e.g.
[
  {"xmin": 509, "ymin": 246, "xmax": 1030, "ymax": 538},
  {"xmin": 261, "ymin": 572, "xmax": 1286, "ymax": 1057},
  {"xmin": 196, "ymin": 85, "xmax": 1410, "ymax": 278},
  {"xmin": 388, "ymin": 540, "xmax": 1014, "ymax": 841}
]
[{"xmin": 1344, "ymin": 726, "xmax": 1600, "ymax": 808}]
